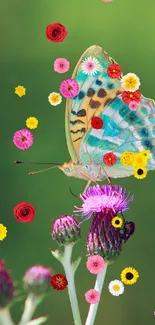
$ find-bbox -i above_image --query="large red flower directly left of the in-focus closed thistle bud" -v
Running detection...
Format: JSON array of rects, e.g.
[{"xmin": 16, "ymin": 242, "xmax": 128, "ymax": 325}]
[{"xmin": 13, "ymin": 202, "xmax": 36, "ymax": 223}]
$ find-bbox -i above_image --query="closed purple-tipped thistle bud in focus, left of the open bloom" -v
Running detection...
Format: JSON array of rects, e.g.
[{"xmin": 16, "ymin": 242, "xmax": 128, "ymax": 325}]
[{"xmin": 52, "ymin": 216, "xmax": 81, "ymax": 245}]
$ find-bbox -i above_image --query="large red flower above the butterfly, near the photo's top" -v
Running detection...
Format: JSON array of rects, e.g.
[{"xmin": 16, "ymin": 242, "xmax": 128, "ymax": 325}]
[{"xmin": 46, "ymin": 23, "xmax": 67, "ymax": 43}]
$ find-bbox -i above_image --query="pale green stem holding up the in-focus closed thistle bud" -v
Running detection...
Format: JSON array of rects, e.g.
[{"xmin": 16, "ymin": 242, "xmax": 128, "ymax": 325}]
[{"xmin": 61, "ymin": 244, "xmax": 82, "ymax": 325}]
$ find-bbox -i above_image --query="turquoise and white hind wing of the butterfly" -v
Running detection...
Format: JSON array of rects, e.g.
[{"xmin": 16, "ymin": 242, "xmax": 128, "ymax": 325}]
[{"xmin": 80, "ymin": 95, "xmax": 155, "ymax": 178}]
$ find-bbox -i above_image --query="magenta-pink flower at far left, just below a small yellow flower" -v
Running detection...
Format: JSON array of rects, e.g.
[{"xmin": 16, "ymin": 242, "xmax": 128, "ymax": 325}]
[{"xmin": 13, "ymin": 129, "xmax": 33, "ymax": 150}]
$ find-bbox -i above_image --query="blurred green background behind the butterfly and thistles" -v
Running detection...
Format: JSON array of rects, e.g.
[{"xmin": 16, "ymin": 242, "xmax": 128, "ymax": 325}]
[{"xmin": 0, "ymin": 0, "xmax": 155, "ymax": 325}]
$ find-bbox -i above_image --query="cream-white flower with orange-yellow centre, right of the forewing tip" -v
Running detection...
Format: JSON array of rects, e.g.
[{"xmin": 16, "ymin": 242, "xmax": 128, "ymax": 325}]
[{"xmin": 121, "ymin": 72, "xmax": 140, "ymax": 92}]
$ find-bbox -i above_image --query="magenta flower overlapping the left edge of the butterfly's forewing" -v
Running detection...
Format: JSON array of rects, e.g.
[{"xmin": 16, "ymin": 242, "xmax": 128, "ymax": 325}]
[{"xmin": 60, "ymin": 79, "xmax": 79, "ymax": 98}]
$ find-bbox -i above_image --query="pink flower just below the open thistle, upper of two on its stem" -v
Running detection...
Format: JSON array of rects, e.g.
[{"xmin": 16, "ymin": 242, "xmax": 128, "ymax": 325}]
[{"xmin": 86, "ymin": 255, "xmax": 106, "ymax": 274}]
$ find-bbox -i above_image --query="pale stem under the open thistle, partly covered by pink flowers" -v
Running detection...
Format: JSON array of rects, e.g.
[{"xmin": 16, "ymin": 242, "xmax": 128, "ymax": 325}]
[{"xmin": 85, "ymin": 263, "xmax": 108, "ymax": 325}]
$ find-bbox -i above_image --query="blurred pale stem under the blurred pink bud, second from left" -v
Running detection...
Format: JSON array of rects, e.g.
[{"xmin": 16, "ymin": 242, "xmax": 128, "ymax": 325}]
[{"xmin": 19, "ymin": 294, "xmax": 43, "ymax": 325}]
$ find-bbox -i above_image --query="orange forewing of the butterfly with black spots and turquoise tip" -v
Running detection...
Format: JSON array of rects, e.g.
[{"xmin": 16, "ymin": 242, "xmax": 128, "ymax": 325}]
[{"xmin": 65, "ymin": 45, "xmax": 121, "ymax": 162}]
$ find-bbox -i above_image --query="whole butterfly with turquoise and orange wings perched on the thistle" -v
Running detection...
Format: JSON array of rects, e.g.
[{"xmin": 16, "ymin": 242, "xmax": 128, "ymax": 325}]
[{"xmin": 17, "ymin": 45, "xmax": 155, "ymax": 187}]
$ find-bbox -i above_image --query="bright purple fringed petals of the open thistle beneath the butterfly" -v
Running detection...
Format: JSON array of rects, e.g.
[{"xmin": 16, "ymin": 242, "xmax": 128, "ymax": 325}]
[{"xmin": 74, "ymin": 185, "xmax": 133, "ymax": 220}]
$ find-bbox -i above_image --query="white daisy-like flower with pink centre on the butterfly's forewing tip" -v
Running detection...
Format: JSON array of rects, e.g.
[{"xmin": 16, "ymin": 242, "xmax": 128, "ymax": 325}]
[{"xmin": 81, "ymin": 56, "xmax": 100, "ymax": 76}]
